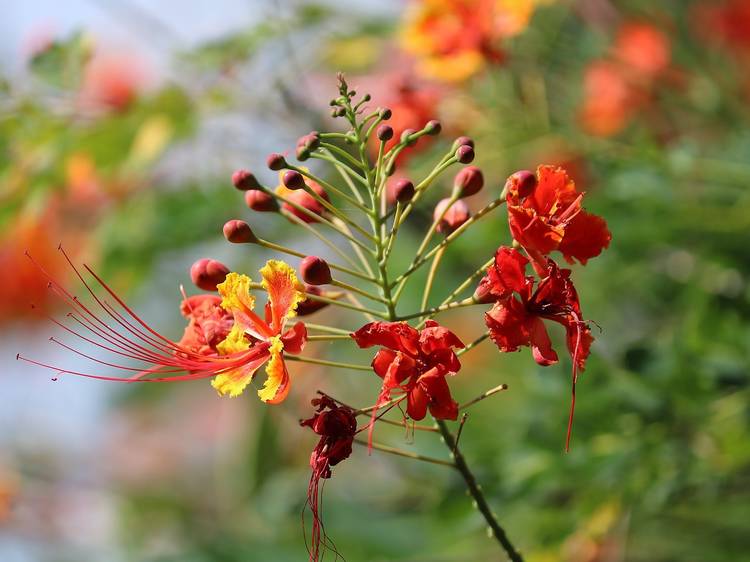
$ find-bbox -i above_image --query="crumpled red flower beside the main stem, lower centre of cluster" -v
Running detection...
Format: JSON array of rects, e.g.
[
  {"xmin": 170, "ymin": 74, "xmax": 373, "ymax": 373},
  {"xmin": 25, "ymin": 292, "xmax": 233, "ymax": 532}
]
[{"xmin": 352, "ymin": 320, "xmax": 464, "ymax": 420}]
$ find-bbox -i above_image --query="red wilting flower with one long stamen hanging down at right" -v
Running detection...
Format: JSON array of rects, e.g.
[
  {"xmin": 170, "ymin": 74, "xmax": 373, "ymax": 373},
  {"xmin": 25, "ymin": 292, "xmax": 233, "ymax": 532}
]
[{"xmin": 478, "ymin": 246, "xmax": 594, "ymax": 449}]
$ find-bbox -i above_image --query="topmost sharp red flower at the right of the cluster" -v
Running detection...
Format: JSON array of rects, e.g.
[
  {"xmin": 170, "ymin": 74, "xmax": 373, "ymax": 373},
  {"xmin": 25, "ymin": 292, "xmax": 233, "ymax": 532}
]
[{"xmin": 506, "ymin": 166, "xmax": 612, "ymax": 264}]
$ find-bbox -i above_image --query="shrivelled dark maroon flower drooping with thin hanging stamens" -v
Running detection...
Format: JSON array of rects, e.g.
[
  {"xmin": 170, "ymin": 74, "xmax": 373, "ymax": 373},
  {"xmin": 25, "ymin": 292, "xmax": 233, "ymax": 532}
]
[{"xmin": 300, "ymin": 396, "xmax": 357, "ymax": 561}]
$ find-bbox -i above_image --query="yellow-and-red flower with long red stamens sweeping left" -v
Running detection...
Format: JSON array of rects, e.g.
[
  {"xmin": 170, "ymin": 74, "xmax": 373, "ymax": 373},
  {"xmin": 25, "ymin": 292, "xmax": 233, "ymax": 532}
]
[{"xmin": 17, "ymin": 248, "xmax": 307, "ymax": 404}]
